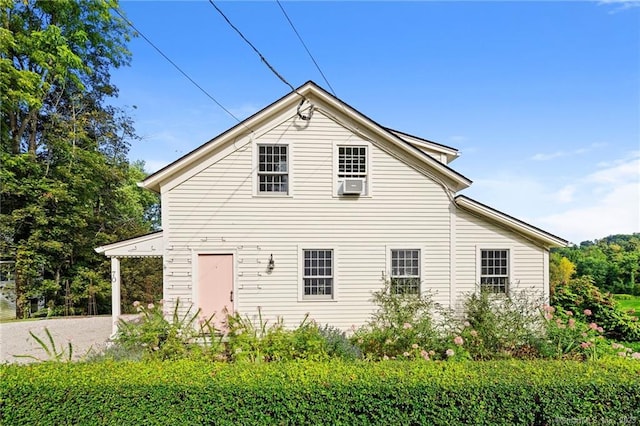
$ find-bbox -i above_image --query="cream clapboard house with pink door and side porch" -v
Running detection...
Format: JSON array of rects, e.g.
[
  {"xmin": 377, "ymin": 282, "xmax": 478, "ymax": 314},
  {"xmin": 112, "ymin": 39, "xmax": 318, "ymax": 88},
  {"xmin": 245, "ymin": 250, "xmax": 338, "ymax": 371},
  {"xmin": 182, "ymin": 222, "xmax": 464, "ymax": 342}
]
[{"xmin": 96, "ymin": 82, "xmax": 567, "ymax": 329}]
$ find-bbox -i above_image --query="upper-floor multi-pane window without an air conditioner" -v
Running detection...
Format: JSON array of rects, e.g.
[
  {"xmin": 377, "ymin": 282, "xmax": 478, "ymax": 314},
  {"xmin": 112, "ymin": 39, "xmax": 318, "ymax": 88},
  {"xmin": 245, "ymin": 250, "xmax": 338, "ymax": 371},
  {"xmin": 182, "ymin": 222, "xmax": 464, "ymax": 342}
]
[{"xmin": 258, "ymin": 145, "xmax": 289, "ymax": 194}]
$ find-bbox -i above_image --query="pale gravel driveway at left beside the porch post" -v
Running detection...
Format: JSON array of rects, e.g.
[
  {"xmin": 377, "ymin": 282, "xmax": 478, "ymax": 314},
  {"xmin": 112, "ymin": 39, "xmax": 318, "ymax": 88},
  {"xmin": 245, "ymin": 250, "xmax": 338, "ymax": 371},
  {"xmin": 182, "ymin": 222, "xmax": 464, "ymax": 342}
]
[{"xmin": 0, "ymin": 315, "xmax": 111, "ymax": 363}]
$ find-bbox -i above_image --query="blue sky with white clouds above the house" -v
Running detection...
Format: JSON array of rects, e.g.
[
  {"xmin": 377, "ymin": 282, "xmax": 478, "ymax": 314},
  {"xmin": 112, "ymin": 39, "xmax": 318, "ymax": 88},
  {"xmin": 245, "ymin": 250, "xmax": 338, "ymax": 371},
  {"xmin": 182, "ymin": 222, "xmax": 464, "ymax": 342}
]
[{"xmin": 113, "ymin": 0, "xmax": 640, "ymax": 243}]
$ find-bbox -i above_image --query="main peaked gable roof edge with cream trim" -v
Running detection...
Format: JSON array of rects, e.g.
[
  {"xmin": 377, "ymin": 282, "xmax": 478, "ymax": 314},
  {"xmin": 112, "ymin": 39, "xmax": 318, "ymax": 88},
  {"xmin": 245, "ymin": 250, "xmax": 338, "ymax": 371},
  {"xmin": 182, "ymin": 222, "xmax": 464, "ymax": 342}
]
[{"xmin": 140, "ymin": 81, "xmax": 471, "ymax": 192}]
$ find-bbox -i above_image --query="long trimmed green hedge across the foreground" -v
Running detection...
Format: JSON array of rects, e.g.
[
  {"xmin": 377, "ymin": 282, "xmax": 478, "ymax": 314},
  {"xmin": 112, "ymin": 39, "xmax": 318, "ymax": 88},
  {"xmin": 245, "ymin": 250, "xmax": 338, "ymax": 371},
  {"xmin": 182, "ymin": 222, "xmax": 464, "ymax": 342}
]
[{"xmin": 0, "ymin": 360, "xmax": 640, "ymax": 426}]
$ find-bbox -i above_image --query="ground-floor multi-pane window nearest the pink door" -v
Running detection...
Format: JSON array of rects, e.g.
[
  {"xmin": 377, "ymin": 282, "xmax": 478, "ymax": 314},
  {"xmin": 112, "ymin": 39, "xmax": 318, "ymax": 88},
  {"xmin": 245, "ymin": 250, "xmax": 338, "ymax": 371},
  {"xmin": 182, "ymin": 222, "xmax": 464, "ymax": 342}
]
[{"xmin": 302, "ymin": 250, "xmax": 333, "ymax": 299}]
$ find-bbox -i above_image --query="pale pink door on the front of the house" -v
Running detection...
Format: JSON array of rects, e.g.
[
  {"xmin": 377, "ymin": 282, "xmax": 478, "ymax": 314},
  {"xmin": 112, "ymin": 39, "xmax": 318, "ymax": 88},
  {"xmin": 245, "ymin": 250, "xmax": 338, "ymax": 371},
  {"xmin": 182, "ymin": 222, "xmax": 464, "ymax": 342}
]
[{"xmin": 198, "ymin": 254, "xmax": 233, "ymax": 328}]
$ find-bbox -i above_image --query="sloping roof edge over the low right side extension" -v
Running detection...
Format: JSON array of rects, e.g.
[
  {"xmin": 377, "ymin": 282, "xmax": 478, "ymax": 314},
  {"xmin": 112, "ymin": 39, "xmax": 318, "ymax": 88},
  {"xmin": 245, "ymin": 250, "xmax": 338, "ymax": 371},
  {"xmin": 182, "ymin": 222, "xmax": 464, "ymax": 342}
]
[{"xmin": 455, "ymin": 195, "xmax": 569, "ymax": 248}]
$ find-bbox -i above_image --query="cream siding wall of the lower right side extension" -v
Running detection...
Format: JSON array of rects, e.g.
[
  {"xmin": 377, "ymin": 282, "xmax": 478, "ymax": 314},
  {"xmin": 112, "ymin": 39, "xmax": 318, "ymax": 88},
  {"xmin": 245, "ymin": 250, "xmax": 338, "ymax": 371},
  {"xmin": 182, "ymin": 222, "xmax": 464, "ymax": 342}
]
[{"xmin": 455, "ymin": 208, "xmax": 549, "ymax": 310}]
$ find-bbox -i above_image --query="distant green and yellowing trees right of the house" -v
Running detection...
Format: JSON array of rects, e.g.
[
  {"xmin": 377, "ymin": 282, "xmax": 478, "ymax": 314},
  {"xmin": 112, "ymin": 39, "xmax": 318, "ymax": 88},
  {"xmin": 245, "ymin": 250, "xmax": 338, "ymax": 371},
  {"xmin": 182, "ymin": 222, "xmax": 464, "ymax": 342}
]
[{"xmin": 550, "ymin": 233, "xmax": 640, "ymax": 294}]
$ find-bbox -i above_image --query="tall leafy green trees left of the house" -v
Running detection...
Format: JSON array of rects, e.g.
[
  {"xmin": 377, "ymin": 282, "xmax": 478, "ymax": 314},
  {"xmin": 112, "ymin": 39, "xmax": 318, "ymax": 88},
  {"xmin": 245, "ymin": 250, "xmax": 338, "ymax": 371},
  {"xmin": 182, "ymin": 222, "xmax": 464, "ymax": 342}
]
[{"xmin": 0, "ymin": 0, "xmax": 158, "ymax": 315}]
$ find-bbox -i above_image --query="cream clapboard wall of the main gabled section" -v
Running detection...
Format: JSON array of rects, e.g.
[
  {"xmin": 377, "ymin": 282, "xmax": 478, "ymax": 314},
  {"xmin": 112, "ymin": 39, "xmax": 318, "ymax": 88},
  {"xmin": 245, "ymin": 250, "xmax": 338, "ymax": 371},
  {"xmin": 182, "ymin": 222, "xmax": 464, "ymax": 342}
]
[{"xmin": 162, "ymin": 105, "xmax": 451, "ymax": 329}]
